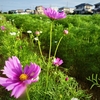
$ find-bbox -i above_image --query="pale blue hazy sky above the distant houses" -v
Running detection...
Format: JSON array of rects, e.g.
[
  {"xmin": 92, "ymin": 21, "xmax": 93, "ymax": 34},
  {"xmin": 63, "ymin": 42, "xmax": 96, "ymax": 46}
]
[{"xmin": 0, "ymin": 0, "xmax": 100, "ymax": 12}]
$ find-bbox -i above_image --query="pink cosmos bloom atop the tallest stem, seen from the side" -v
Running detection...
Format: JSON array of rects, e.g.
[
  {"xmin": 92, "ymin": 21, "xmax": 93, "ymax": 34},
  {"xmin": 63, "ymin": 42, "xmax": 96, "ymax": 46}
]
[{"xmin": 44, "ymin": 8, "xmax": 66, "ymax": 19}]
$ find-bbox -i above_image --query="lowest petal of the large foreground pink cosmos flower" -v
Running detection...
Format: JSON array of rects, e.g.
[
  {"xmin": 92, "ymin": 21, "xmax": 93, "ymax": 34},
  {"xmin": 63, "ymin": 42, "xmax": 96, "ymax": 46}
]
[{"xmin": 11, "ymin": 84, "xmax": 26, "ymax": 98}]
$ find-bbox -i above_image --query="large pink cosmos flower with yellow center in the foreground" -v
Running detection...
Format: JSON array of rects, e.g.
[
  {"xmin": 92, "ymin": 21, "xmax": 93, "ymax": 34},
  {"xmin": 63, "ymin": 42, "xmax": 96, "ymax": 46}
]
[{"xmin": 0, "ymin": 56, "xmax": 41, "ymax": 98}]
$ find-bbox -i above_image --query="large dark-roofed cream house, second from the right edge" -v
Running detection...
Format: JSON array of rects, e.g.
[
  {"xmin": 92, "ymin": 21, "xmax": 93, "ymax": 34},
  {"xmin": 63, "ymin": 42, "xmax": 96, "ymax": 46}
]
[{"xmin": 74, "ymin": 3, "xmax": 93, "ymax": 14}]
